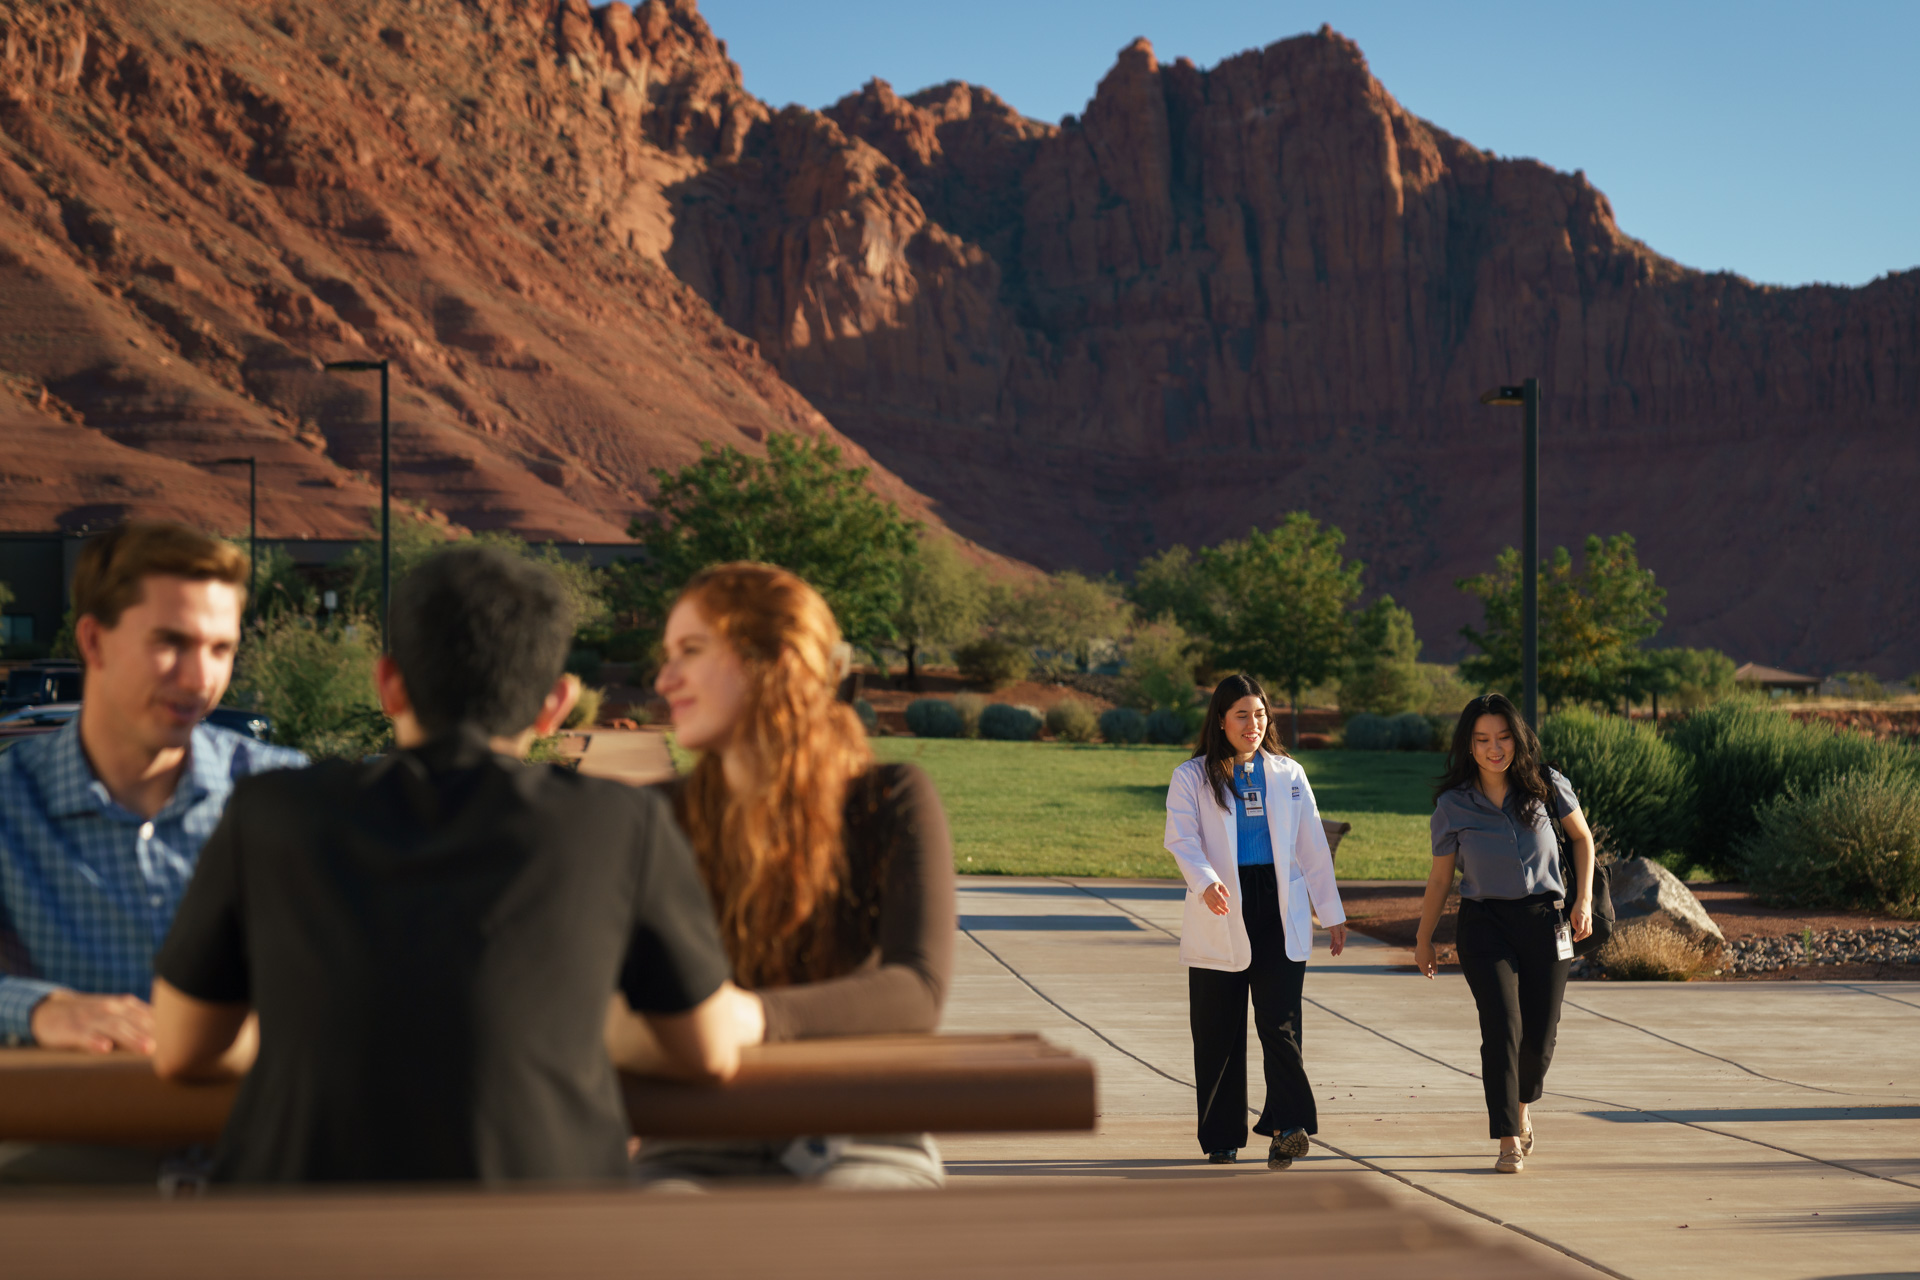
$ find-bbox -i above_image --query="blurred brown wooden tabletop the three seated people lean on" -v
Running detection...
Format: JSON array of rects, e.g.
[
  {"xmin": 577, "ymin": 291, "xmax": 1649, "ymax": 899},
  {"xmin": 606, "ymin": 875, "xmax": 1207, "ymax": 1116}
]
[{"xmin": 0, "ymin": 1034, "xmax": 1094, "ymax": 1146}]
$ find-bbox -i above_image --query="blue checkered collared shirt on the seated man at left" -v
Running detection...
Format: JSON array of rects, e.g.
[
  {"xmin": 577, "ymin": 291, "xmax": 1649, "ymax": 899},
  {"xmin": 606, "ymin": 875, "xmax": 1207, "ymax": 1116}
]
[{"xmin": 0, "ymin": 716, "xmax": 307, "ymax": 1044}]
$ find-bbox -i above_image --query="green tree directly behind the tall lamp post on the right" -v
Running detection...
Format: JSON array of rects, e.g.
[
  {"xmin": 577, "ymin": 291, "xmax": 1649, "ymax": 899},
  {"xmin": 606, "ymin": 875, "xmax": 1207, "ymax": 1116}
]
[{"xmin": 1455, "ymin": 533, "xmax": 1667, "ymax": 710}]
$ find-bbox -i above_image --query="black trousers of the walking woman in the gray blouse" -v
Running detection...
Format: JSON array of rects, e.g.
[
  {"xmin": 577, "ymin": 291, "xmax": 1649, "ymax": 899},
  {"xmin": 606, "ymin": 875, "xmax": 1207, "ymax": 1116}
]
[{"xmin": 1457, "ymin": 894, "xmax": 1572, "ymax": 1138}]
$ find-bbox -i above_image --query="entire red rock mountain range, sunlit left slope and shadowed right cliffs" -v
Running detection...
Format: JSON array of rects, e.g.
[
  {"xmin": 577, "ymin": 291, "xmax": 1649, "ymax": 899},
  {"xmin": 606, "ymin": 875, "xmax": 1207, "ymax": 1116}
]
[{"xmin": 0, "ymin": 0, "xmax": 1920, "ymax": 676}]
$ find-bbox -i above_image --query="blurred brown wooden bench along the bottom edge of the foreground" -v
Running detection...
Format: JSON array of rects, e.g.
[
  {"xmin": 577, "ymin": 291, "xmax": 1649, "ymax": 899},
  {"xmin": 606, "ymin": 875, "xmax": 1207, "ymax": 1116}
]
[{"xmin": 0, "ymin": 1163, "xmax": 1590, "ymax": 1280}]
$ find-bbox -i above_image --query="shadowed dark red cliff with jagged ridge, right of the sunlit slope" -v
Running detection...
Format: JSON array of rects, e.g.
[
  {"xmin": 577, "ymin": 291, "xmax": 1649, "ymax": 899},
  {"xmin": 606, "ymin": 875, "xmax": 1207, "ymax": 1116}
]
[{"xmin": 652, "ymin": 29, "xmax": 1920, "ymax": 672}]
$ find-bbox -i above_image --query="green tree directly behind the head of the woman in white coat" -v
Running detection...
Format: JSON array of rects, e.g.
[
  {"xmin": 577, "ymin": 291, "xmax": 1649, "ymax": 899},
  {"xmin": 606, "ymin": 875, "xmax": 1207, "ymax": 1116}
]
[{"xmin": 1200, "ymin": 510, "xmax": 1363, "ymax": 745}]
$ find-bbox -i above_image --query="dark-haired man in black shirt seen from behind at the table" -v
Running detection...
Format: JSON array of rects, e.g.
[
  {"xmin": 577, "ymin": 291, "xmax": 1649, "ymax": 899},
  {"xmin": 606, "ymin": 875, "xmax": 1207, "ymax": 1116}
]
[{"xmin": 154, "ymin": 547, "xmax": 741, "ymax": 1182}]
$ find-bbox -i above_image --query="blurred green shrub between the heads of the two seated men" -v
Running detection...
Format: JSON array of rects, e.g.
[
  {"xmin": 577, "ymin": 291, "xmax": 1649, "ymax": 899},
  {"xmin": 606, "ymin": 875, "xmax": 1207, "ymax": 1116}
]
[{"xmin": 232, "ymin": 614, "xmax": 392, "ymax": 760}]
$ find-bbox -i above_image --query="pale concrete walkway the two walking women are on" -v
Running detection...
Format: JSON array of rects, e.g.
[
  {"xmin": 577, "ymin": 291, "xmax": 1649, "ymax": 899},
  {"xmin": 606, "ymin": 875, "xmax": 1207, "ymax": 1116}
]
[{"xmin": 943, "ymin": 877, "xmax": 1920, "ymax": 1280}]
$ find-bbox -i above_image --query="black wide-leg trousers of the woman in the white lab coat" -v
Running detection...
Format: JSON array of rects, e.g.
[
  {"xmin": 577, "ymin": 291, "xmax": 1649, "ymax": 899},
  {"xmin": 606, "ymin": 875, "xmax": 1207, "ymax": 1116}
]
[{"xmin": 1187, "ymin": 865, "xmax": 1319, "ymax": 1151}]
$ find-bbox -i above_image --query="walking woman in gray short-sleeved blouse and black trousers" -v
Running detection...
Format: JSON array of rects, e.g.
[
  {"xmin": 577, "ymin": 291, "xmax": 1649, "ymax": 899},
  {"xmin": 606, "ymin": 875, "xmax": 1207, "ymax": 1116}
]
[{"xmin": 1413, "ymin": 693, "xmax": 1594, "ymax": 1173}]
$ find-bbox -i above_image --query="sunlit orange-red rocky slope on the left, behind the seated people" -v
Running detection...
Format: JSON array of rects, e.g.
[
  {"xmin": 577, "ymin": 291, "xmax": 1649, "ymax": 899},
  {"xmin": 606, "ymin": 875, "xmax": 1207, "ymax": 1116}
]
[{"xmin": 0, "ymin": 0, "xmax": 952, "ymax": 539}]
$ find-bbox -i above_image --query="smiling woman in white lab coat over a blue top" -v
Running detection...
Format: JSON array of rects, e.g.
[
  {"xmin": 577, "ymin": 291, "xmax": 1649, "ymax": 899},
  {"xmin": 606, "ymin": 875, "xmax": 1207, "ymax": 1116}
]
[{"xmin": 1165, "ymin": 676, "xmax": 1346, "ymax": 1169}]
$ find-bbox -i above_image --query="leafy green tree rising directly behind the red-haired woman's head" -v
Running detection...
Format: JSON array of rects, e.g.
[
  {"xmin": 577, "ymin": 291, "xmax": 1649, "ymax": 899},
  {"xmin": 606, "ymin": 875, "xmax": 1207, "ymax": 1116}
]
[{"xmin": 618, "ymin": 432, "xmax": 914, "ymax": 658}]
